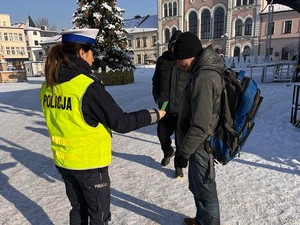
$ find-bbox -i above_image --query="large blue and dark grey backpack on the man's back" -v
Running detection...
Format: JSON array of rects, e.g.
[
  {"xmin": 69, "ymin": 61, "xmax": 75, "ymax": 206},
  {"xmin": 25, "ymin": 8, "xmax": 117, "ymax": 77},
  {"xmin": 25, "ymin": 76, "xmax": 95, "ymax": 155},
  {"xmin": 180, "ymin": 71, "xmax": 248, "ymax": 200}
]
[{"xmin": 201, "ymin": 67, "xmax": 263, "ymax": 165}]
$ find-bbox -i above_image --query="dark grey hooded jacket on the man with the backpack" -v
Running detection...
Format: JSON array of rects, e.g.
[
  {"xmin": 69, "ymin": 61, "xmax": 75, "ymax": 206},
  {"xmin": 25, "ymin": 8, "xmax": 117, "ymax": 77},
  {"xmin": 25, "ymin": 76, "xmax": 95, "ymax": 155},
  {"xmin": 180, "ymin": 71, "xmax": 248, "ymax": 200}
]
[{"xmin": 177, "ymin": 46, "xmax": 225, "ymax": 159}]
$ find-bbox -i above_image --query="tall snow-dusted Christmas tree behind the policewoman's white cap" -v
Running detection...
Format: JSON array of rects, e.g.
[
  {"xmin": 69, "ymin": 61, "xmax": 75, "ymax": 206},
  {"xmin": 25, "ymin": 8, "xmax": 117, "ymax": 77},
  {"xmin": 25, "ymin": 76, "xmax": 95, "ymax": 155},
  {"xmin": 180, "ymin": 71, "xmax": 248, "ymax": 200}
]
[{"xmin": 72, "ymin": 0, "xmax": 134, "ymax": 72}]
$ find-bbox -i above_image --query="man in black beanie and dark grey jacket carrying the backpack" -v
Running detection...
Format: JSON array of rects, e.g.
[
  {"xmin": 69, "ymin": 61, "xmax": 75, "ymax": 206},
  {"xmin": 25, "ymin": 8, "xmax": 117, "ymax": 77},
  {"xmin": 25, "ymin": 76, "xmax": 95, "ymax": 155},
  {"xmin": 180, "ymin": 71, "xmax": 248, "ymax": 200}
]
[{"xmin": 174, "ymin": 32, "xmax": 225, "ymax": 225}]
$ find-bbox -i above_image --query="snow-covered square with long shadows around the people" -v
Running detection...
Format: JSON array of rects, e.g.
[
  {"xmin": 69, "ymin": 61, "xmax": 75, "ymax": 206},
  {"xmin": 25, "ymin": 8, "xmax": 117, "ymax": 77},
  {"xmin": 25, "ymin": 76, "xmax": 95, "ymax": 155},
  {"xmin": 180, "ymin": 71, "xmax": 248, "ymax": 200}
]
[{"xmin": 0, "ymin": 68, "xmax": 300, "ymax": 225}]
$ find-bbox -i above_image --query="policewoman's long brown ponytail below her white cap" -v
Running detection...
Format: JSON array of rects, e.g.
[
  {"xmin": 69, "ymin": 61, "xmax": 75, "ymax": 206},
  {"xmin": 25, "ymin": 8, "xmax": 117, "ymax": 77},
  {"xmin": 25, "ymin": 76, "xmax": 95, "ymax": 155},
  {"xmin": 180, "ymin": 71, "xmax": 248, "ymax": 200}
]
[{"xmin": 45, "ymin": 43, "xmax": 91, "ymax": 88}]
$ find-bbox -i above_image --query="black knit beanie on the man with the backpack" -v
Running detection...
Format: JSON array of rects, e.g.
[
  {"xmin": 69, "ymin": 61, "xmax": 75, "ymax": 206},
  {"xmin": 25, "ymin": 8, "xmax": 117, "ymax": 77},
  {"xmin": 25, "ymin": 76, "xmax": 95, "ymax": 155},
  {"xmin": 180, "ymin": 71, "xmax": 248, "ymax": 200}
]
[{"xmin": 174, "ymin": 32, "xmax": 203, "ymax": 59}]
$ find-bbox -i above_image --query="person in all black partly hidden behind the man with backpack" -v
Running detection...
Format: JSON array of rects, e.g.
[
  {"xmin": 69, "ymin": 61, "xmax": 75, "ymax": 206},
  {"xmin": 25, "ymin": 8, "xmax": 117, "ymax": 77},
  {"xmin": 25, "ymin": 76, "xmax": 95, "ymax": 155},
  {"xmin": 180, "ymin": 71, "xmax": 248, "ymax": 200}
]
[{"xmin": 152, "ymin": 30, "xmax": 188, "ymax": 178}]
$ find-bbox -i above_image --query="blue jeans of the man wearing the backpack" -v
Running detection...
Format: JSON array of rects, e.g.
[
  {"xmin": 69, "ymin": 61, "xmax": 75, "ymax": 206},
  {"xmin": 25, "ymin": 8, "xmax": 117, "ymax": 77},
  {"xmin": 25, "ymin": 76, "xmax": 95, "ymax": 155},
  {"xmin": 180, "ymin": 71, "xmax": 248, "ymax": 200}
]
[{"xmin": 188, "ymin": 150, "xmax": 220, "ymax": 225}]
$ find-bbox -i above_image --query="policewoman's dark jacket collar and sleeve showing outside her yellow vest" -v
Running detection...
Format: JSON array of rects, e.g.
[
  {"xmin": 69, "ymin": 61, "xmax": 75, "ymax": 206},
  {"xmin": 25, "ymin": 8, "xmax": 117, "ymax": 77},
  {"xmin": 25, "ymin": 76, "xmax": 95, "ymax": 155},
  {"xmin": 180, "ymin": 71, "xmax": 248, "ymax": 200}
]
[{"xmin": 58, "ymin": 55, "xmax": 155, "ymax": 133}]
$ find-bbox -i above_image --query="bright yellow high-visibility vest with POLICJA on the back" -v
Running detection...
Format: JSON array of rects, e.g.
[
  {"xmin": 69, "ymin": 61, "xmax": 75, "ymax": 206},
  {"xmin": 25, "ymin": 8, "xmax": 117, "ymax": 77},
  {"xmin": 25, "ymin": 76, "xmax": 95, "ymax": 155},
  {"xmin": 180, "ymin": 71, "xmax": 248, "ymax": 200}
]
[{"xmin": 40, "ymin": 74, "xmax": 112, "ymax": 170}]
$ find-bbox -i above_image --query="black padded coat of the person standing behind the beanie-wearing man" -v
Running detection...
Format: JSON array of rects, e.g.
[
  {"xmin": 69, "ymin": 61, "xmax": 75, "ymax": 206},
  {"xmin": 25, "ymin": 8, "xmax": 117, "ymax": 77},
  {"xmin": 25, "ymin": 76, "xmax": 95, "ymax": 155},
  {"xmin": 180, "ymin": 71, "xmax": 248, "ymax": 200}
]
[{"xmin": 152, "ymin": 51, "xmax": 189, "ymax": 113}]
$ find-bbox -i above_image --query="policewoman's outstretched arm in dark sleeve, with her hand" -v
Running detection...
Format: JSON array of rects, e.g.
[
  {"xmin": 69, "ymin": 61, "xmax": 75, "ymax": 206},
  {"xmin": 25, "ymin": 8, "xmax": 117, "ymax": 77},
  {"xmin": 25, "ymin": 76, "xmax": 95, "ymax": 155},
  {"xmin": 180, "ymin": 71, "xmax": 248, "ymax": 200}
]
[{"xmin": 82, "ymin": 82, "xmax": 158, "ymax": 133}]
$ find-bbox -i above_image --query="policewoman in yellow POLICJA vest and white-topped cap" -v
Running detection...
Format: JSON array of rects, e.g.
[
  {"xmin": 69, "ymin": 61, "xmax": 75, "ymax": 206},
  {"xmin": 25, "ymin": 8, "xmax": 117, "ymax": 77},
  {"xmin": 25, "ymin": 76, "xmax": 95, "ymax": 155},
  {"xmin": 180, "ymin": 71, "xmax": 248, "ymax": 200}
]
[{"xmin": 40, "ymin": 29, "xmax": 165, "ymax": 225}]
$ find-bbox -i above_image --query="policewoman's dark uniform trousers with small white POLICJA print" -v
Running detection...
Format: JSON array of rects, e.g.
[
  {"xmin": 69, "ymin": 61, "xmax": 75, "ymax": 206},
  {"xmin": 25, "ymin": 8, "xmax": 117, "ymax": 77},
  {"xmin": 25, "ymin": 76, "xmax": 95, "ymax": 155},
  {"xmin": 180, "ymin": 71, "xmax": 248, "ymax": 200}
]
[{"xmin": 58, "ymin": 167, "xmax": 111, "ymax": 225}]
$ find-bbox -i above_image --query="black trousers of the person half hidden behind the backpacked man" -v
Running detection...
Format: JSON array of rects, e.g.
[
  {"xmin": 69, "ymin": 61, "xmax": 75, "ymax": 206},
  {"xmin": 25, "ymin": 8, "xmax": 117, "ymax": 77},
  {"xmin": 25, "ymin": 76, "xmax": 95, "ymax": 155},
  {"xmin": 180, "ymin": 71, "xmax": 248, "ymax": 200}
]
[{"xmin": 157, "ymin": 113, "xmax": 179, "ymax": 168}]
